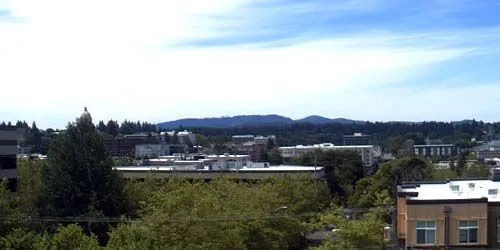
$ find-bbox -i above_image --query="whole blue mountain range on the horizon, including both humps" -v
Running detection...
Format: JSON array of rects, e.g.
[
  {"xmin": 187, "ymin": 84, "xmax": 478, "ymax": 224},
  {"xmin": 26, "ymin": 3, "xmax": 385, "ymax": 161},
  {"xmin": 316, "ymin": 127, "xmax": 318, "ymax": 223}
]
[{"xmin": 158, "ymin": 115, "xmax": 364, "ymax": 129}]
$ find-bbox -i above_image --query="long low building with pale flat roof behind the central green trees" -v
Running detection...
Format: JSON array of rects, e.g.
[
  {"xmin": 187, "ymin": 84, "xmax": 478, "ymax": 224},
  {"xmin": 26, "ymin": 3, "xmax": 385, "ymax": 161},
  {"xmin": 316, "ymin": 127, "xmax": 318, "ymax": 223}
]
[{"xmin": 114, "ymin": 166, "xmax": 325, "ymax": 180}]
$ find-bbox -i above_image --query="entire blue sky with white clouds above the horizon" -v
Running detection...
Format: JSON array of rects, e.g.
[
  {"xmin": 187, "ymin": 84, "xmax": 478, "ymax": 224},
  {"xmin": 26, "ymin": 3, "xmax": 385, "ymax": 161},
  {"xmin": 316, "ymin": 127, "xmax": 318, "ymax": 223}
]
[{"xmin": 0, "ymin": 0, "xmax": 500, "ymax": 128}]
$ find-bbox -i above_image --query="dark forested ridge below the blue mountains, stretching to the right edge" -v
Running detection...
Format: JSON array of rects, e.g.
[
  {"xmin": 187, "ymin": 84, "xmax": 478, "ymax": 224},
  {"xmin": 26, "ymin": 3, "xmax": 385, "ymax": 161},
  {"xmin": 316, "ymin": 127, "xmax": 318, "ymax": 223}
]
[{"xmin": 189, "ymin": 121, "xmax": 500, "ymax": 151}]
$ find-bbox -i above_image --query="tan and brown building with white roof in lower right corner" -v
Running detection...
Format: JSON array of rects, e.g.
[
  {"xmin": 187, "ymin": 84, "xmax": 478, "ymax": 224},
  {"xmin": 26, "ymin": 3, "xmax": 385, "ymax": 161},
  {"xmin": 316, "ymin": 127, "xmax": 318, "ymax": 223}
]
[{"xmin": 396, "ymin": 169, "xmax": 500, "ymax": 249}]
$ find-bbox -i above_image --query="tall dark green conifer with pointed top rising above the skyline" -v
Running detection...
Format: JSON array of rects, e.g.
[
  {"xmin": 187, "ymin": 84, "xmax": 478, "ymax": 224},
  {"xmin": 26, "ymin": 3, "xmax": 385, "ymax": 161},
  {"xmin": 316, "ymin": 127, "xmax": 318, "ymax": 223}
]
[{"xmin": 38, "ymin": 109, "xmax": 124, "ymax": 234}]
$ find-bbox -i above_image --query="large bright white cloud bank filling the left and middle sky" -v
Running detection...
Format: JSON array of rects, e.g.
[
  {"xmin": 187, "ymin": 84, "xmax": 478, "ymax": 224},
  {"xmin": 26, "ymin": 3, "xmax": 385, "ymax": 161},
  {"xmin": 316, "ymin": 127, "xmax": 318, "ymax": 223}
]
[{"xmin": 0, "ymin": 0, "xmax": 492, "ymax": 127}]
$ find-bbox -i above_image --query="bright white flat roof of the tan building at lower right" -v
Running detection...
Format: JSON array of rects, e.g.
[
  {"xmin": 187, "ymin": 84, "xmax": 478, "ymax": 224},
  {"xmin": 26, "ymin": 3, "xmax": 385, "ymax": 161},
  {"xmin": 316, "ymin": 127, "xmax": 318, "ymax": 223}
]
[{"xmin": 398, "ymin": 179, "xmax": 500, "ymax": 202}]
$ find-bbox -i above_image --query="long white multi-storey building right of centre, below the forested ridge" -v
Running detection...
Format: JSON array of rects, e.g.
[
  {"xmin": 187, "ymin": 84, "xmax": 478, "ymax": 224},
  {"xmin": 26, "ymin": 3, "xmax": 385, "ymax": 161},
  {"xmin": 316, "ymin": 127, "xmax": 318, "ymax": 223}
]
[{"xmin": 280, "ymin": 143, "xmax": 377, "ymax": 166}]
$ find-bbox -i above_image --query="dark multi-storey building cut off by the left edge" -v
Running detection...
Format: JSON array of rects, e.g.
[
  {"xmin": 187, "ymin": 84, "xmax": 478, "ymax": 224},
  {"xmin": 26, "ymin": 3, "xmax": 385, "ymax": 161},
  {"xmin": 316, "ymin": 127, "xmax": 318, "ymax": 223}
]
[{"xmin": 0, "ymin": 126, "xmax": 18, "ymax": 190}]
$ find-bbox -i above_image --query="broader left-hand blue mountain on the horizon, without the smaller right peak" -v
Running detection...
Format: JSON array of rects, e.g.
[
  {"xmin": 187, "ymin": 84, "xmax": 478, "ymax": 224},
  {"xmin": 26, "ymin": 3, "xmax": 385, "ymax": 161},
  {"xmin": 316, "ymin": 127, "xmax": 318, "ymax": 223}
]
[{"xmin": 158, "ymin": 115, "xmax": 294, "ymax": 129}]
